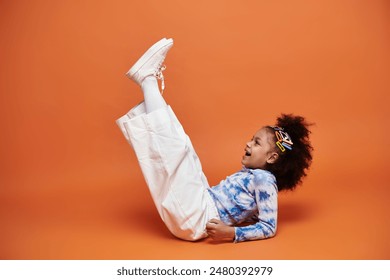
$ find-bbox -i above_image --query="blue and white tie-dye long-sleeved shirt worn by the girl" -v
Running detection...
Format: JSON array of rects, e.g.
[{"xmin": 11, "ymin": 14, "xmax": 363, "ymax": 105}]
[{"xmin": 209, "ymin": 167, "xmax": 278, "ymax": 242}]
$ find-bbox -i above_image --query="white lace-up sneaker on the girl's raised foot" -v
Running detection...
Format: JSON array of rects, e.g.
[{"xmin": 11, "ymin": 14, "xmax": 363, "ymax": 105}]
[{"xmin": 126, "ymin": 38, "xmax": 173, "ymax": 90}]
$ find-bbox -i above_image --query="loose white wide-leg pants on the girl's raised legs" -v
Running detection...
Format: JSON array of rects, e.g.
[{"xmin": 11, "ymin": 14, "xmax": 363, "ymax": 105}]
[{"xmin": 116, "ymin": 103, "xmax": 219, "ymax": 241}]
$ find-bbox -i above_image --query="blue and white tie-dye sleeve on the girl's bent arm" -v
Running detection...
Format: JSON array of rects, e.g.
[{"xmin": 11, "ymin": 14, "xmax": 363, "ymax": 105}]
[{"xmin": 234, "ymin": 179, "xmax": 278, "ymax": 242}]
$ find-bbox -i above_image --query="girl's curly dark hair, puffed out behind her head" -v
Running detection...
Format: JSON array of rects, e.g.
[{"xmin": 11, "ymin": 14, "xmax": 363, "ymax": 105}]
[{"xmin": 267, "ymin": 114, "xmax": 313, "ymax": 191}]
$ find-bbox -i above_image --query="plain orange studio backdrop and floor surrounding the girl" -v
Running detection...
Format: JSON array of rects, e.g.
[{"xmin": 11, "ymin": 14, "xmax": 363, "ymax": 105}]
[{"xmin": 0, "ymin": 0, "xmax": 390, "ymax": 259}]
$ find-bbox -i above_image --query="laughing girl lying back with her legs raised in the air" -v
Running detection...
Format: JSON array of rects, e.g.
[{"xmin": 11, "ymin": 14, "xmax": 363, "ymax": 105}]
[{"xmin": 117, "ymin": 38, "xmax": 312, "ymax": 242}]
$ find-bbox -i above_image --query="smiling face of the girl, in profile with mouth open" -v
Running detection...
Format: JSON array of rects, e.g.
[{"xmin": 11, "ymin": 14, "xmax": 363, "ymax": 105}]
[{"xmin": 241, "ymin": 127, "xmax": 279, "ymax": 169}]
